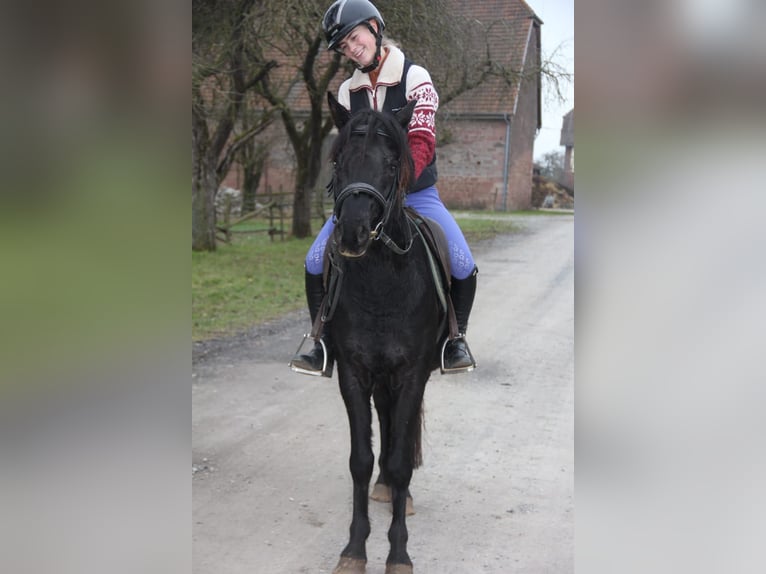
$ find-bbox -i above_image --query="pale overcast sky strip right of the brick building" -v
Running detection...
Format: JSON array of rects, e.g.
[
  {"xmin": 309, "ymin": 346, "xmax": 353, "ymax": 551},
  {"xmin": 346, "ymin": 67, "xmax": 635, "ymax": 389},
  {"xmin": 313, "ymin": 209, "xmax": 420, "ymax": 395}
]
[{"xmin": 526, "ymin": 0, "xmax": 574, "ymax": 159}]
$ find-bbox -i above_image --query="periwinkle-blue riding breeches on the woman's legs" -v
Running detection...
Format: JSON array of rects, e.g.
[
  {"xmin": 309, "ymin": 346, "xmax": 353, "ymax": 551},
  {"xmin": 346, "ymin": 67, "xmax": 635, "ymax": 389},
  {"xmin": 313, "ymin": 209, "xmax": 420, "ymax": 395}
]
[{"xmin": 306, "ymin": 186, "xmax": 475, "ymax": 279}]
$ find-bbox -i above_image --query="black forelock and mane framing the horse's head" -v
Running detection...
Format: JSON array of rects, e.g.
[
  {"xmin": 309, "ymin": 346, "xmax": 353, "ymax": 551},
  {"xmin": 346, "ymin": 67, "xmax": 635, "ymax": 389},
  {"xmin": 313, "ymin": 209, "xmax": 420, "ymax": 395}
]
[{"xmin": 330, "ymin": 109, "xmax": 415, "ymax": 193}]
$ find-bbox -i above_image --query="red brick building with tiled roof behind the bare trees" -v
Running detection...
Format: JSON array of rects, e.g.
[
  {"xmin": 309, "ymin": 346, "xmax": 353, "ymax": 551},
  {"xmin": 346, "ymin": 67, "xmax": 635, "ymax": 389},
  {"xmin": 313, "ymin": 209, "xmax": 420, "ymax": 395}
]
[{"xmin": 223, "ymin": 0, "xmax": 542, "ymax": 214}]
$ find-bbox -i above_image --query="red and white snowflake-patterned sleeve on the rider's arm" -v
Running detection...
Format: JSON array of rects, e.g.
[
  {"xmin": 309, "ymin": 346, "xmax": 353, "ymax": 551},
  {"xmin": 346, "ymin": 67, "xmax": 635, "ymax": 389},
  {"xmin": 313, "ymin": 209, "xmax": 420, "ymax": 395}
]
[{"xmin": 407, "ymin": 73, "xmax": 439, "ymax": 179}]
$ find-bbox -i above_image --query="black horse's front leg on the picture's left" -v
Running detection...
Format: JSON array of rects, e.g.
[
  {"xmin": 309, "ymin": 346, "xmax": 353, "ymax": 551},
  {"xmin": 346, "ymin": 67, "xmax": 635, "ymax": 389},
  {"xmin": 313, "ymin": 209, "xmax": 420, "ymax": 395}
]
[{"xmin": 333, "ymin": 372, "xmax": 374, "ymax": 574}]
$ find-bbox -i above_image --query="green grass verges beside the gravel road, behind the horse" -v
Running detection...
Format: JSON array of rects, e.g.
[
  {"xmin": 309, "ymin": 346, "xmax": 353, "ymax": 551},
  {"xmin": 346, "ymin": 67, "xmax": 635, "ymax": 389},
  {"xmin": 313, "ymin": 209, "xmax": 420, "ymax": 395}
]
[{"xmin": 192, "ymin": 212, "xmax": 520, "ymax": 341}]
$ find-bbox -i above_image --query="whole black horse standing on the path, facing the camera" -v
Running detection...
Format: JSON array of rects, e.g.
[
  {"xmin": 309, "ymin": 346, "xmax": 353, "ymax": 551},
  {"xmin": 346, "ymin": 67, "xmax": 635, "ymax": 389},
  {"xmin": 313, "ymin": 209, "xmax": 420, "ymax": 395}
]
[{"xmin": 328, "ymin": 94, "xmax": 449, "ymax": 574}]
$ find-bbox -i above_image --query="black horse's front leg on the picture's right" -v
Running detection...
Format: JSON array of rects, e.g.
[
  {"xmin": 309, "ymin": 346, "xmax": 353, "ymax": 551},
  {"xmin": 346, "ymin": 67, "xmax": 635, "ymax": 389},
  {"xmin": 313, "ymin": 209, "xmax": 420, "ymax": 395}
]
[{"xmin": 386, "ymin": 374, "xmax": 427, "ymax": 574}]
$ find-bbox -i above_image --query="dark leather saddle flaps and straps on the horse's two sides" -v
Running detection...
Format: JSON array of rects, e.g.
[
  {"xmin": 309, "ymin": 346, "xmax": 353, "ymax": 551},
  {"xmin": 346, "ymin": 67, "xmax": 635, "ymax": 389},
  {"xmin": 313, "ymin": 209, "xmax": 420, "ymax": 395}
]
[{"xmin": 311, "ymin": 213, "xmax": 459, "ymax": 341}]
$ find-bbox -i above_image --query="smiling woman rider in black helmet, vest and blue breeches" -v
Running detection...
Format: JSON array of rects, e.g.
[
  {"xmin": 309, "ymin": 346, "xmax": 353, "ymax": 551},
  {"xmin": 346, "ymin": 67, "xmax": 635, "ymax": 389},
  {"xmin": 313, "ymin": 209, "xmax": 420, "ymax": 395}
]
[{"xmin": 290, "ymin": 0, "xmax": 478, "ymax": 377}]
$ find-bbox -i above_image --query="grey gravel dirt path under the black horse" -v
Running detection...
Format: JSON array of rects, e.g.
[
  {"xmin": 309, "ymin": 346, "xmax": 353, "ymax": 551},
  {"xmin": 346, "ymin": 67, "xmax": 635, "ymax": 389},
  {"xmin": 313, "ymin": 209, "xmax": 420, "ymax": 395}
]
[{"xmin": 192, "ymin": 215, "xmax": 574, "ymax": 574}]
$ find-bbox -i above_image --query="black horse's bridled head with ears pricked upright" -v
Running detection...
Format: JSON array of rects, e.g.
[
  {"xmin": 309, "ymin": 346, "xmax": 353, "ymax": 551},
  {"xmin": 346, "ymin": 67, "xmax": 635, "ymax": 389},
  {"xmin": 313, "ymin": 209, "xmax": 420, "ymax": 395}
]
[{"xmin": 327, "ymin": 93, "xmax": 416, "ymax": 257}]
